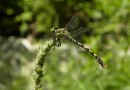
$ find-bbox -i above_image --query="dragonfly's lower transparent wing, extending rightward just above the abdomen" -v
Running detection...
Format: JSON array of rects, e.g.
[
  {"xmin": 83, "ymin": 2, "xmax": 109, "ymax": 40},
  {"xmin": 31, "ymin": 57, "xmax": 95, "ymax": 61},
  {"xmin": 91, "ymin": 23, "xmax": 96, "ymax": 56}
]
[{"xmin": 70, "ymin": 27, "xmax": 89, "ymax": 38}]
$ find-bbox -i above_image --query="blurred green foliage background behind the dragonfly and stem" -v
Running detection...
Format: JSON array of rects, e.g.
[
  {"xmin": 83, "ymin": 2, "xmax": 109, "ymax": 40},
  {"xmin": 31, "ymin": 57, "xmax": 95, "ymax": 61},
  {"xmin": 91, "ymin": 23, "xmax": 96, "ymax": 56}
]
[{"xmin": 0, "ymin": 0, "xmax": 130, "ymax": 90}]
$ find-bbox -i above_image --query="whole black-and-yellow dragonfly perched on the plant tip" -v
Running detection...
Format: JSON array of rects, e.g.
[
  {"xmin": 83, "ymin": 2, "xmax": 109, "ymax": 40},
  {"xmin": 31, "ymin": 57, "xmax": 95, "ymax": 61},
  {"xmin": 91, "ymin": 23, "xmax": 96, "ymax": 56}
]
[{"xmin": 51, "ymin": 15, "xmax": 106, "ymax": 69}]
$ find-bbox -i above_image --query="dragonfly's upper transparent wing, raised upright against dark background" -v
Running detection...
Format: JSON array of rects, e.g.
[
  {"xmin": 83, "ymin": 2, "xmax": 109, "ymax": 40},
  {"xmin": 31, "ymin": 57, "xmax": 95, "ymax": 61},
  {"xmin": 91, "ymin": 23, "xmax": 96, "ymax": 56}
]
[{"xmin": 65, "ymin": 16, "xmax": 79, "ymax": 31}]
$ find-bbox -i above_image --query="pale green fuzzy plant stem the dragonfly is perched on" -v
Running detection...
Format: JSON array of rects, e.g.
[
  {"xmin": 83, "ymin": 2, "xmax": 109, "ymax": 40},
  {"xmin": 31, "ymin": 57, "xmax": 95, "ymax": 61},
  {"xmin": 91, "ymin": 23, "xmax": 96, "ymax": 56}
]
[{"xmin": 33, "ymin": 39, "xmax": 56, "ymax": 90}]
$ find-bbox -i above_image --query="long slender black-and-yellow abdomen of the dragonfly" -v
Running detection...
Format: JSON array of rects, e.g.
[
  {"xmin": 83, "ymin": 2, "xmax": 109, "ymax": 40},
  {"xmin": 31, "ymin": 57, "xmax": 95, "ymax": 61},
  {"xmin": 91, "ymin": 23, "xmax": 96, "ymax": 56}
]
[{"xmin": 68, "ymin": 36, "xmax": 106, "ymax": 69}]
